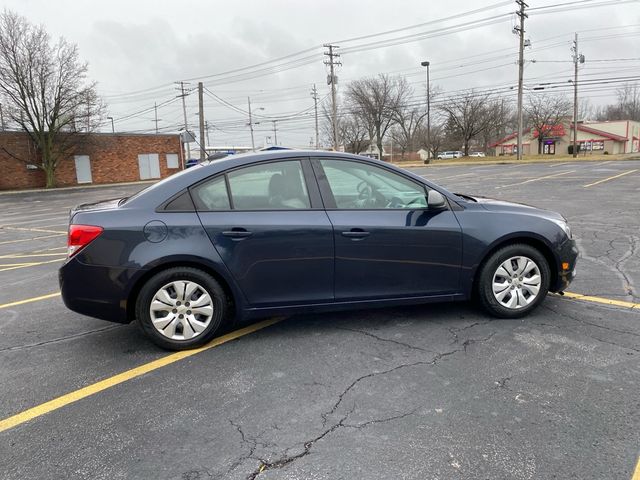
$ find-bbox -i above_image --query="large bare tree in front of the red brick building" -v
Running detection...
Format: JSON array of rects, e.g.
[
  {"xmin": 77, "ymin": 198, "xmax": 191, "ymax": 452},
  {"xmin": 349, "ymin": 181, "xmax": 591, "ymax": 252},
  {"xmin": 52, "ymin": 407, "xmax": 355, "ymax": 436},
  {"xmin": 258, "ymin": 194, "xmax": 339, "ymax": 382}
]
[{"xmin": 0, "ymin": 10, "xmax": 104, "ymax": 187}]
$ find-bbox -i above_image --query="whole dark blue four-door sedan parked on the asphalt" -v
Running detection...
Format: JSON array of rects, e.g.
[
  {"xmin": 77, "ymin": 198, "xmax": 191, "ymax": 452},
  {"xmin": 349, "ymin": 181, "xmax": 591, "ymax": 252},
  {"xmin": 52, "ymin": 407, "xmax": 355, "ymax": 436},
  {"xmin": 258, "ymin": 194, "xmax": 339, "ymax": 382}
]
[{"xmin": 59, "ymin": 150, "xmax": 578, "ymax": 349}]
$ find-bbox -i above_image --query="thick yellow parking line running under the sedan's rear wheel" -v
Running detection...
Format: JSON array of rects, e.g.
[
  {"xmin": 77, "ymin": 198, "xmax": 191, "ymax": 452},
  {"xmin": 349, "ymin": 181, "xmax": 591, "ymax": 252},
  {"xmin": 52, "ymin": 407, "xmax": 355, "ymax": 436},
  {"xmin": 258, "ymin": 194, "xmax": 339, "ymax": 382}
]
[{"xmin": 0, "ymin": 317, "xmax": 284, "ymax": 432}]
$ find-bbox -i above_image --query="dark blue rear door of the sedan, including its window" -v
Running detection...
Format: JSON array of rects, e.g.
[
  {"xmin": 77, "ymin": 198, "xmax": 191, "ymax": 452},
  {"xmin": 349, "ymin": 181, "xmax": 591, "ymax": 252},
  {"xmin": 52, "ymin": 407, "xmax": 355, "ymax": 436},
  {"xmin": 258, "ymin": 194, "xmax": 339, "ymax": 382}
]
[{"xmin": 191, "ymin": 158, "xmax": 334, "ymax": 307}]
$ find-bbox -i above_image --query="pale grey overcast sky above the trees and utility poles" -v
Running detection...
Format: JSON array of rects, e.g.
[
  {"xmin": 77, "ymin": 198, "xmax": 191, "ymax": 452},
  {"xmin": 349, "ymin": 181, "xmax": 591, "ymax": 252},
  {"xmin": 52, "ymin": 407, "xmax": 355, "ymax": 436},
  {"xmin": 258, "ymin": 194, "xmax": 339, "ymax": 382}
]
[{"xmin": 4, "ymin": 0, "xmax": 640, "ymax": 150}]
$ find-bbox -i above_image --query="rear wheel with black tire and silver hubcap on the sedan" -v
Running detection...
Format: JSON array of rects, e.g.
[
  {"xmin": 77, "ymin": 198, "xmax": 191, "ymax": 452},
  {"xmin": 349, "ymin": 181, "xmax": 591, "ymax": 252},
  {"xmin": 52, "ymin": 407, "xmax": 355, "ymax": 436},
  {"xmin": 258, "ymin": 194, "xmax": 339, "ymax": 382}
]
[{"xmin": 136, "ymin": 267, "xmax": 227, "ymax": 350}]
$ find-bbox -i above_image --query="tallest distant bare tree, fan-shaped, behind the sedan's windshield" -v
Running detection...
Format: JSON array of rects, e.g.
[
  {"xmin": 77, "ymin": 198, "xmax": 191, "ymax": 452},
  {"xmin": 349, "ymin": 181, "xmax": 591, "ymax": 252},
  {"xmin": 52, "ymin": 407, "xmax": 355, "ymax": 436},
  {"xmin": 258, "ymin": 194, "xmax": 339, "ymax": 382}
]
[{"xmin": 346, "ymin": 75, "xmax": 409, "ymax": 159}]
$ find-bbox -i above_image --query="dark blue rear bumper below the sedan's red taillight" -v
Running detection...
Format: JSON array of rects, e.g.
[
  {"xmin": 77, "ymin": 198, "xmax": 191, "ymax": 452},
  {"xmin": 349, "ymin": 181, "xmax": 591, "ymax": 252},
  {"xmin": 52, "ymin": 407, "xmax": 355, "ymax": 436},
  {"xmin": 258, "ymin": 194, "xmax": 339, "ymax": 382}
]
[{"xmin": 58, "ymin": 258, "xmax": 140, "ymax": 323}]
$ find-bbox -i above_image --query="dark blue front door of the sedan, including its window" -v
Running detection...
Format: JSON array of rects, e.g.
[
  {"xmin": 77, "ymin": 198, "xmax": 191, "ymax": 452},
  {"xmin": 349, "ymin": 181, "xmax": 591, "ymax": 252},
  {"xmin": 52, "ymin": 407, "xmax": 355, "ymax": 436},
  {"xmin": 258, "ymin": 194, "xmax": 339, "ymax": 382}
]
[{"xmin": 313, "ymin": 158, "xmax": 462, "ymax": 300}]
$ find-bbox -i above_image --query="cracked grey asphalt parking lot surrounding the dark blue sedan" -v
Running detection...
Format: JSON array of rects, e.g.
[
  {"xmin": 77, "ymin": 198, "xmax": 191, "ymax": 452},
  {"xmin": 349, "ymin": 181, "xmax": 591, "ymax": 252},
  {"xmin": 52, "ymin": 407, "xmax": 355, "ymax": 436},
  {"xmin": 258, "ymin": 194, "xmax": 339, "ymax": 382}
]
[{"xmin": 0, "ymin": 161, "xmax": 640, "ymax": 480}]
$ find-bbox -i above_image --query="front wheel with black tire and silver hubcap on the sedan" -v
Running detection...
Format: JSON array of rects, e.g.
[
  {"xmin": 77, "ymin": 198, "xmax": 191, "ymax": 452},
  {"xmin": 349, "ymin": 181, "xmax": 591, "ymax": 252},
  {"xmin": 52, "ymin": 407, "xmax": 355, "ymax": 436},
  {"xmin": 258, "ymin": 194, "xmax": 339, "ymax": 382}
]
[{"xmin": 477, "ymin": 244, "xmax": 551, "ymax": 318}]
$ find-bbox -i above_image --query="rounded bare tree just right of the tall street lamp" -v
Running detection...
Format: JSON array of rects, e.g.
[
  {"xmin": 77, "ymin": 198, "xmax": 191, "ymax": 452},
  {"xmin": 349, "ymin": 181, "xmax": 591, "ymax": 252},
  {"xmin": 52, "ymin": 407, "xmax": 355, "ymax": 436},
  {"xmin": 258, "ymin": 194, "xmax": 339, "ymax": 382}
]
[{"xmin": 439, "ymin": 90, "xmax": 493, "ymax": 155}]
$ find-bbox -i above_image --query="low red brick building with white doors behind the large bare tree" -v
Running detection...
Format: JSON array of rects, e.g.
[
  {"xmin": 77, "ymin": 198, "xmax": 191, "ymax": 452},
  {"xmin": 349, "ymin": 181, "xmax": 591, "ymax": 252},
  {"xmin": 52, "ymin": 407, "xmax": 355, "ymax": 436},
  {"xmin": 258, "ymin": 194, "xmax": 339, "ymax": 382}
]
[{"xmin": 0, "ymin": 132, "xmax": 183, "ymax": 190}]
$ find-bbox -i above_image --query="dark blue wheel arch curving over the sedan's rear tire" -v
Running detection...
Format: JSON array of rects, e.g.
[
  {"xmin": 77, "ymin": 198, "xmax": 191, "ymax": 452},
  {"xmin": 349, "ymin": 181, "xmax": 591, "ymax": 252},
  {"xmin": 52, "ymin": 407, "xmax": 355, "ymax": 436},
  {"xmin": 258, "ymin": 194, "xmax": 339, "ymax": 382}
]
[{"xmin": 127, "ymin": 257, "xmax": 243, "ymax": 321}]
